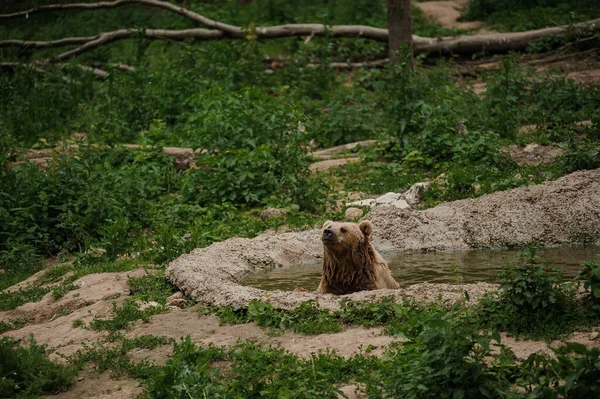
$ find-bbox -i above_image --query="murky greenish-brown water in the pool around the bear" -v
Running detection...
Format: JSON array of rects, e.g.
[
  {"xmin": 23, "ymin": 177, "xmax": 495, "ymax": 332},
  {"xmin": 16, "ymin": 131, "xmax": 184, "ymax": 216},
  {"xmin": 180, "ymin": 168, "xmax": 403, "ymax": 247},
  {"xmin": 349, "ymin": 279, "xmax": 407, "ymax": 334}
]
[{"xmin": 241, "ymin": 245, "xmax": 600, "ymax": 291}]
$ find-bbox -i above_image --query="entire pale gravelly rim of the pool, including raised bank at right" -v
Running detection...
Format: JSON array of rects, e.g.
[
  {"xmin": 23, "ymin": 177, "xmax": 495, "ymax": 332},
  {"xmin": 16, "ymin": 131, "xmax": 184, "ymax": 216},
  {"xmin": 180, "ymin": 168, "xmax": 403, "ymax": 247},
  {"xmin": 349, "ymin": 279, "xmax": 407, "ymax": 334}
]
[{"xmin": 167, "ymin": 169, "xmax": 600, "ymax": 308}]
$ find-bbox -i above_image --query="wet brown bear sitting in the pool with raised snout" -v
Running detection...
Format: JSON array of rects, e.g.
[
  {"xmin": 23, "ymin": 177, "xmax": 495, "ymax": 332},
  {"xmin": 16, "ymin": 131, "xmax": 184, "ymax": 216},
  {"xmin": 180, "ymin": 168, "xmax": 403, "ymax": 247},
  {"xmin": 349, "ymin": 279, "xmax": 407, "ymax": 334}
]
[{"xmin": 317, "ymin": 220, "xmax": 400, "ymax": 295}]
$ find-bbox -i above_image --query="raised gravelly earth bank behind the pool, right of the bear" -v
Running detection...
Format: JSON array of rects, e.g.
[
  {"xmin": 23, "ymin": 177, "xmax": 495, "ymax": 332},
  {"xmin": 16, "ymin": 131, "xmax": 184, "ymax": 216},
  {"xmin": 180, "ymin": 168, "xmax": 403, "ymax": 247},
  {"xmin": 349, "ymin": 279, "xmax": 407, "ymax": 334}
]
[{"xmin": 368, "ymin": 169, "xmax": 600, "ymax": 251}]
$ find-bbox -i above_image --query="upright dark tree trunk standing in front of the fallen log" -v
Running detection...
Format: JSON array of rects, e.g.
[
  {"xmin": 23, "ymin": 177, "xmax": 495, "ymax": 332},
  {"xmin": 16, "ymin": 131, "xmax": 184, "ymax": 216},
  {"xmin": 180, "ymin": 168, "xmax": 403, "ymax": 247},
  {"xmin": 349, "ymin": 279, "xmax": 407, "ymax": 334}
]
[{"xmin": 387, "ymin": 0, "xmax": 413, "ymax": 68}]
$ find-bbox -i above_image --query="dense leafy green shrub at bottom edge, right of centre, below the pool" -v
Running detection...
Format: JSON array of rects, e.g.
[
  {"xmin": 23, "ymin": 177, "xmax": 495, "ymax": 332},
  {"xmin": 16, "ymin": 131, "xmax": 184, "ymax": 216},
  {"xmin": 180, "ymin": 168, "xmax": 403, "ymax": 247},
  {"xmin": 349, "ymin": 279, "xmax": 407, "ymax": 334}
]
[{"xmin": 376, "ymin": 312, "xmax": 509, "ymax": 398}]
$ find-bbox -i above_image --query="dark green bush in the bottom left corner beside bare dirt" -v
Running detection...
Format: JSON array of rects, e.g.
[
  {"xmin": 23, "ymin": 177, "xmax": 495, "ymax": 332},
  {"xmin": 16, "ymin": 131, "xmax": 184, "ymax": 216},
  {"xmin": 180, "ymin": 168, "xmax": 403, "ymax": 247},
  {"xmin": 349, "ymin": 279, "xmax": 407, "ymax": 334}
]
[{"xmin": 0, "ymin": 337, "xmax": 76, "ymax": 398}]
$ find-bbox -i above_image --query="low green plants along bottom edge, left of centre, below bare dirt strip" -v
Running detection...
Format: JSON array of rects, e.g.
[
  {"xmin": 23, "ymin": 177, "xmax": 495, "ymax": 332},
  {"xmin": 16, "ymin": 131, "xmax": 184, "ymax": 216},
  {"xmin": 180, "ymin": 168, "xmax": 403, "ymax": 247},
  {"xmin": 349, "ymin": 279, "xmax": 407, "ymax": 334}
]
[{"xmin": 147, "ymin": 337, "xmax": 370, "ymax": 398}]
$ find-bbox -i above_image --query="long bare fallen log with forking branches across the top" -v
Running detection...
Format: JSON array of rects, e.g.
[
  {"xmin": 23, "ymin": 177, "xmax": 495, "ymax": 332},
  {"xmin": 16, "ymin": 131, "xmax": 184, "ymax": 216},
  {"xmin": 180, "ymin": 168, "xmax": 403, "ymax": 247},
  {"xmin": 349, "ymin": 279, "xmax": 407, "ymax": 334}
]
[{"xmin": 0, "ymin": 0, "xmax": 600, "ymax": 60}]
